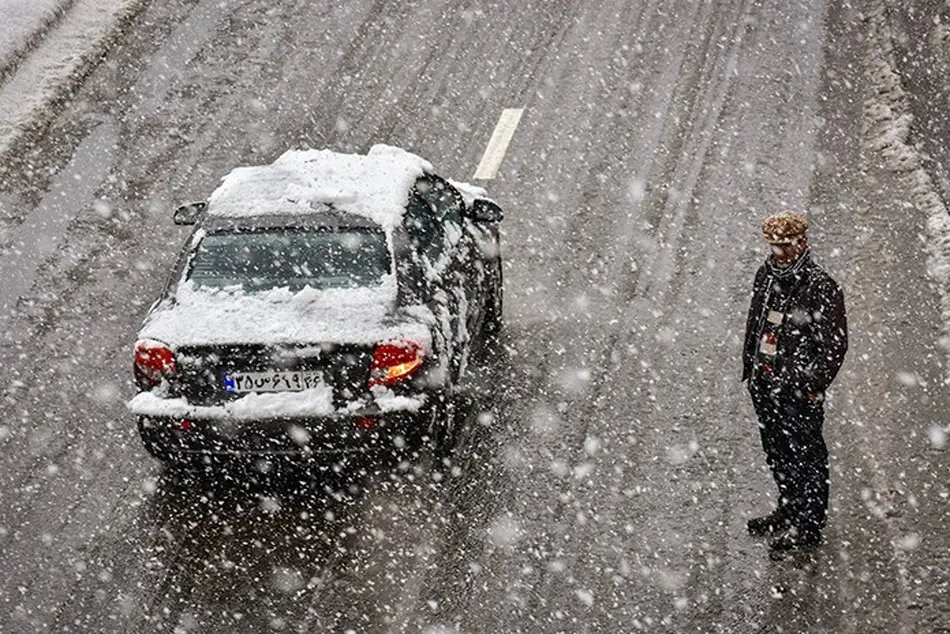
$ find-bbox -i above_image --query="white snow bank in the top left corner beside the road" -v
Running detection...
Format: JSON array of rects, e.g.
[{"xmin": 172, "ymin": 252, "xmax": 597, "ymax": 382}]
[{"xmin": 0, "ymin": 0, "xmax": 144, "ymax": 156}]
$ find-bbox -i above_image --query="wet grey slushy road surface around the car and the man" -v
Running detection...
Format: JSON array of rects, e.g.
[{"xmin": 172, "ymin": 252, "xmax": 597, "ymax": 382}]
[{"xmin": 0, "ymin": 0, "xmax": 950, "ymax": 634}]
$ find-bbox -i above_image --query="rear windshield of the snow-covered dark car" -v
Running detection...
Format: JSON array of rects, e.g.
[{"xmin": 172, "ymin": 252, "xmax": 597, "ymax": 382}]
[{"xmin": 188, "ymin": 228, "xmax": 391, "ymax": 292}]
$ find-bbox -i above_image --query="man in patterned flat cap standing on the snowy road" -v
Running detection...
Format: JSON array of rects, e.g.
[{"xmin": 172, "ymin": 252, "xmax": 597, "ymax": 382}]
[{"xmin": 742, "ymin": 211, "xmax": 848, "ymax": 550}]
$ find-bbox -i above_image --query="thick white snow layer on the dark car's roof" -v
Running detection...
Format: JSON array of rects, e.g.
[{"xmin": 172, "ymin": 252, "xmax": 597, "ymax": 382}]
[{"xmin": 207, "ymin": 145, "xmax": 432, "ymax": 230}]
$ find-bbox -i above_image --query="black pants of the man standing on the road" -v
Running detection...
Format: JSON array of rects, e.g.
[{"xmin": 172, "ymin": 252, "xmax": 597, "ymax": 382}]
[{"xmin": 750, "ymin": 385, "xmax": 828, "ymax": 531}]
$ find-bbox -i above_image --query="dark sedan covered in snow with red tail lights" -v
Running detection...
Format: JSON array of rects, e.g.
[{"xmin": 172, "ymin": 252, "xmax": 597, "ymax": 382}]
[{"xmin": 129, "ymin": 145, "xmax": 510, "ymax": 462}]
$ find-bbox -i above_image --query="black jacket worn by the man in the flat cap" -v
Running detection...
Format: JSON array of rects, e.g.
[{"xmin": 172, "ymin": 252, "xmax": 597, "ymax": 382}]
[{"xmin": 742, "ymin": 250, "xmax": 848, "ymax": 396}]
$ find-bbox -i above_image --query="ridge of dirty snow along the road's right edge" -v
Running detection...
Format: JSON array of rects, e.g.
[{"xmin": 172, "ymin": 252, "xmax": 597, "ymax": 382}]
[{"xmin": 863, "ymin": 2, "xmax": 950, "ymax": 385}]
